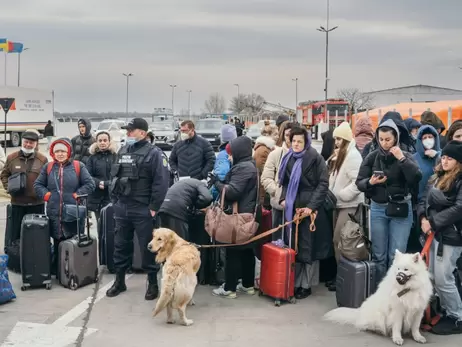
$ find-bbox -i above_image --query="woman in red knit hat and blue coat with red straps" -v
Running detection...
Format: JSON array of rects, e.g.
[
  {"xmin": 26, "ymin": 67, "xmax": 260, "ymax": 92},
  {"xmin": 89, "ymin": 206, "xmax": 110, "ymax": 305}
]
[{"xmin": 34, "ymin": 138, "xmax": 95, "ymax": 271}]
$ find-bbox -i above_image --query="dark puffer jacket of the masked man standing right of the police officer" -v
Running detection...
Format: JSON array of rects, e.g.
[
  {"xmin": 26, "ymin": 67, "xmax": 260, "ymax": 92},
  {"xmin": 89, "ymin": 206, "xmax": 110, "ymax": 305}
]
[{"xmin": 169, "ymin": 134, "xmax": 215, "ymax": 180}]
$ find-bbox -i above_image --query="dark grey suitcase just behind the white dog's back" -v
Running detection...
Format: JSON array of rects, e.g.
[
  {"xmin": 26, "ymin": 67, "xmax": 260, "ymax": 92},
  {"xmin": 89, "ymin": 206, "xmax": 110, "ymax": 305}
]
[{"xmin": 336, "ymin": 255, "xmax": 378, "ymax": 308}]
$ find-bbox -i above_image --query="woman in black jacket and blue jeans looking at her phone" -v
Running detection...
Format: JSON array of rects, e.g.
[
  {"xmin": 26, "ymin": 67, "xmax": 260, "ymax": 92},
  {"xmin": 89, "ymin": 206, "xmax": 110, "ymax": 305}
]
[{"xmin": 356, "ymin": 119, "xmax": 422, "ymax": 282}]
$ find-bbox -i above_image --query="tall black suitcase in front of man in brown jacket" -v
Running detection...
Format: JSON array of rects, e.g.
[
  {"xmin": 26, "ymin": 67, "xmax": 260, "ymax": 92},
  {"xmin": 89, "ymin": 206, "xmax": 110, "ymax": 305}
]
[{"xmin": 20, "ymin": 214, "xmax": 51, "ymax": 291}]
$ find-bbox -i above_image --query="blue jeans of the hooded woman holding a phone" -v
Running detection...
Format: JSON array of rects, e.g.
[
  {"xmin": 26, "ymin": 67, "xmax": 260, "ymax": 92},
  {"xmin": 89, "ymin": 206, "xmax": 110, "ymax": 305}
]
[{"xmin": 370, "ymin": 201, "xmax": 413, "ymax": 282}]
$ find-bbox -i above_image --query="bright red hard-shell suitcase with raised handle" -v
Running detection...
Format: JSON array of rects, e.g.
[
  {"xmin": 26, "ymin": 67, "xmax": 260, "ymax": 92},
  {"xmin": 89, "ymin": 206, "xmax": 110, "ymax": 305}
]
[{"xmin": 259, "ymin": 213, "xmax": 296, "ymax": 306}]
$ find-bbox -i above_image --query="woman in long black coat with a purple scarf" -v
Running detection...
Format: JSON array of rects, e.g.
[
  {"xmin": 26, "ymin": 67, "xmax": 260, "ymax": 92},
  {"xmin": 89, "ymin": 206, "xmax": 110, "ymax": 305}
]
[{"xmin": 279, "ymin": 127, "xmax": 333, "ymax": 299}]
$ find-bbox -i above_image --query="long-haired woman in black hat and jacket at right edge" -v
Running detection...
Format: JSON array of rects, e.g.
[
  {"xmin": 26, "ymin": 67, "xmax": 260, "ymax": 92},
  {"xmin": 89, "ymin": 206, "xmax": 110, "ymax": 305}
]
[{"xmin": 418, "ymin": 141, "xmax": 462, "ymax": 335}]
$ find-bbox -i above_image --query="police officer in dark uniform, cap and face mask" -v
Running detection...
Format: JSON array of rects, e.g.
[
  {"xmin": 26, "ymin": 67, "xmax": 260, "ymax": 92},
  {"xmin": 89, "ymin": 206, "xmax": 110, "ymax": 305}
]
[{"xmin": 106, "ymin": 118, "xmax": 169, "ymax": 300}]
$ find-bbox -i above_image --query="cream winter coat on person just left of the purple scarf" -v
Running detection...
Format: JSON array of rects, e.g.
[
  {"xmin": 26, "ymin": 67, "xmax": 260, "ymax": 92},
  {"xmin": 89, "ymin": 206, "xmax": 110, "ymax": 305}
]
[{"xmin": 261, "ymin": 143, "xmax": 289, "ymax": 210}]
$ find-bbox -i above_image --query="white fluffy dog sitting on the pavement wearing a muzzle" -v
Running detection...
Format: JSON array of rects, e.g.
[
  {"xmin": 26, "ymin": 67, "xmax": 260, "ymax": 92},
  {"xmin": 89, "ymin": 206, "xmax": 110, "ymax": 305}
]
[{"xmin": 324, "ymin": 251, "xmax": 433, "ymax": 346}]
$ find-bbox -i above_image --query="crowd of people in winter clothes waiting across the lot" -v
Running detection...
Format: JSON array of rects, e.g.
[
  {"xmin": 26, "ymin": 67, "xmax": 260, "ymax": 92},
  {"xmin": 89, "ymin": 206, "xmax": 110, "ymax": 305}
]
[{"xmin": 0, "ymin": 112, "xmax": 462, "ymax": 334}]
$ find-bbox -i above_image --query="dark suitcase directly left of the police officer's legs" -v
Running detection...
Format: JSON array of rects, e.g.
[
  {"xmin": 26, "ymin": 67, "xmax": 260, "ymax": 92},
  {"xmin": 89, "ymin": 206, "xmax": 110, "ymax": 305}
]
[{"xmin": 98, "ymin": 204, "xmax": 115, "ymax": 273}]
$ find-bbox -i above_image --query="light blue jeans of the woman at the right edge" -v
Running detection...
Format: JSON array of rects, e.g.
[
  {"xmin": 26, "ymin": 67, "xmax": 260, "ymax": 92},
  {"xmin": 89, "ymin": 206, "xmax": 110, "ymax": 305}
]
[{"xmin": 430, "ymin": 240, "xmax": 462, "ymax": 320}]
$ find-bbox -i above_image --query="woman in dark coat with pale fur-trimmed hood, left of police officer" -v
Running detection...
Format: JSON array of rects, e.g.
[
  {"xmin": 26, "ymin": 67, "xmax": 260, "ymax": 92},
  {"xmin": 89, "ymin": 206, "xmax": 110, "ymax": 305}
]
[{"xmin": 87, "ymin": 131, "xmax": 117, "ymax": 220}]
